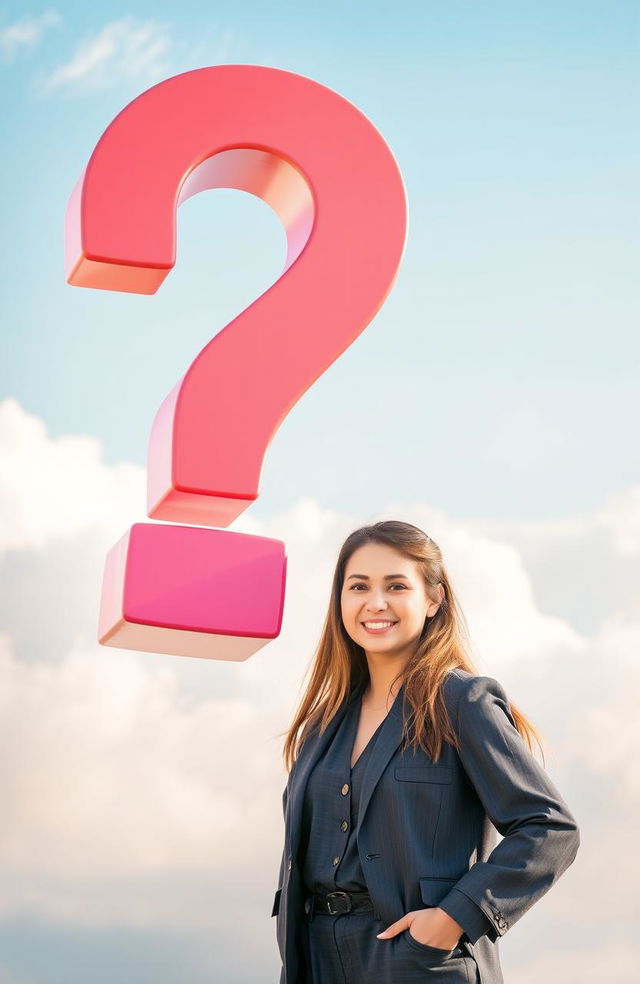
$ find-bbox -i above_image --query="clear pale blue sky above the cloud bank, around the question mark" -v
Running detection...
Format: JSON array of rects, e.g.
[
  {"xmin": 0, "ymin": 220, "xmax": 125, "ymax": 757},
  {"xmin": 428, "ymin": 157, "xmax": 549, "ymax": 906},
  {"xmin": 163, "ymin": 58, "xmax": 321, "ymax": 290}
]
[{"xmin": 0, "ymin": 3, "xmax": 639, "ymax": 518}]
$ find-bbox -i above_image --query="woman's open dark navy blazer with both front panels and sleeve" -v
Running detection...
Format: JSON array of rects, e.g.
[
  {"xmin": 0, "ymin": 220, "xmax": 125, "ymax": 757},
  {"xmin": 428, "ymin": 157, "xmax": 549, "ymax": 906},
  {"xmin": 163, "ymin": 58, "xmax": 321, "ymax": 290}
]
[{"xmin": 271, "ymin": 669, "xmax": 580, "ymax": 984}]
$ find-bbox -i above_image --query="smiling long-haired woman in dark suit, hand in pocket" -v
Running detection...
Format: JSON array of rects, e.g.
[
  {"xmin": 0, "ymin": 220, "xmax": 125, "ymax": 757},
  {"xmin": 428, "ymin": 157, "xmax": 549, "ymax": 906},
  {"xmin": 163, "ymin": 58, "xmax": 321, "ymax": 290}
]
[{"xmin": 272, "ymin": 521, "xmax": 580, "ymax": 984}]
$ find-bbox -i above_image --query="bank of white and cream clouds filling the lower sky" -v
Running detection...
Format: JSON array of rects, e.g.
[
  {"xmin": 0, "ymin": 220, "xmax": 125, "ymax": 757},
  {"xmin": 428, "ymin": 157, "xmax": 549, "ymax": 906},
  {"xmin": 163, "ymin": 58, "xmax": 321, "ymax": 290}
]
[{"xmin": 0, "ymin": 399, "xmax": 640, "ymax": 984}]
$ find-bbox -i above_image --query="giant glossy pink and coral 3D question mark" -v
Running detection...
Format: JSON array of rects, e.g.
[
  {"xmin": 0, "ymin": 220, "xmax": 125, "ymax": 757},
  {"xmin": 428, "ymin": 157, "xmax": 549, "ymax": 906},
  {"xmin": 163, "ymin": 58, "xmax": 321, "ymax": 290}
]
[{"xmin": 65, "ymin": 65, "xmax": 407, "ymax": 660}]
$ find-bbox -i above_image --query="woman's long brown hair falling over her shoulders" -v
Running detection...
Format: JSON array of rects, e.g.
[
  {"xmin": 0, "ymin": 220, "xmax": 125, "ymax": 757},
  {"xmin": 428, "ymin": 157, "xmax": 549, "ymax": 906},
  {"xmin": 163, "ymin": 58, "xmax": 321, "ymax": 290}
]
[{"xmin": 280, "ymin": 520, "xmax": 544, "ymax": 772}]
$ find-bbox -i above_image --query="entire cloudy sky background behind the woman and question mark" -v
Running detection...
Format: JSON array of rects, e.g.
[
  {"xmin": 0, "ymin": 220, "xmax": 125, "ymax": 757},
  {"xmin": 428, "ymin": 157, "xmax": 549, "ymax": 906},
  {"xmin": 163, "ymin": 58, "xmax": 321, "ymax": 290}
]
[{"xmin": 0, "ymin": 0, "xmax": 640, "ymax": 984}]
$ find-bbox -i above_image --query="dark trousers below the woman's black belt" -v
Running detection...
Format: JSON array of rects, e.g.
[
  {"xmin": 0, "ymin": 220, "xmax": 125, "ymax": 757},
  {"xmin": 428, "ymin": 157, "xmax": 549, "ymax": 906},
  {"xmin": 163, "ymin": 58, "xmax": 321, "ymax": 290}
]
[{"xmin": 301, "ymin": 909, "xmax": 479, "ymax": 984}]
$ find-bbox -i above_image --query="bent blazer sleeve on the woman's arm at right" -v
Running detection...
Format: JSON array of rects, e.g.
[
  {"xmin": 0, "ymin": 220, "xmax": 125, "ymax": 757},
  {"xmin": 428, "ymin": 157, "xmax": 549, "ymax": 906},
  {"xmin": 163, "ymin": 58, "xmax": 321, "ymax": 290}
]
[{"xmin": 438, "ymin": 676, "xmax": 580, "ymax": 943}]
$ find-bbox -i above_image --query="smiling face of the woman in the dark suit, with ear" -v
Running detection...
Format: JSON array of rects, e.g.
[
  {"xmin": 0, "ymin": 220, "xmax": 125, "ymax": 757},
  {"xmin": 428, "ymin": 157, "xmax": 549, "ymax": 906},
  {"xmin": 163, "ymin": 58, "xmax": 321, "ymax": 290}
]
[{"xmin": 341, "ymin": 543, "xmax": 444, "ymax": 659}]
